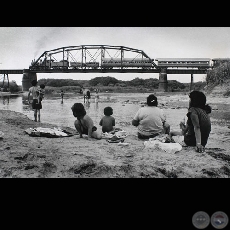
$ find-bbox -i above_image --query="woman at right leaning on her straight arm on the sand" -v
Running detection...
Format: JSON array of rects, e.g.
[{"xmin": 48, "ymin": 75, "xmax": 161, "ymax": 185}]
[{"xmin": 169, "ymin": 90, "xmax": 212, "ymax": 152}]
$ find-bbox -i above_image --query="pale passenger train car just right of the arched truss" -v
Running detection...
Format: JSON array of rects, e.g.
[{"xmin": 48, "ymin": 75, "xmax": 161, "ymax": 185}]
[{"xmin": 155, "ymin": 58, "xmax": 211, "ymax": 69}]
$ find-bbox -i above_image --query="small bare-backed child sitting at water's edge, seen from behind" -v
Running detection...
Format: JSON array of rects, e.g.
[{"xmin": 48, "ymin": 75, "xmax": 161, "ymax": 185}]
[{"xmin": 99, "ymin": 106, "xmax": 115, "ymax": 133}]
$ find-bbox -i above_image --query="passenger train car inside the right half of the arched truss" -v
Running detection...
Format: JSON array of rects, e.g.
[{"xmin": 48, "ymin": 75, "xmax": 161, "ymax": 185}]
[{"xmin": 101, "ymin": 58, "xmax": 153, "ymax": 69}]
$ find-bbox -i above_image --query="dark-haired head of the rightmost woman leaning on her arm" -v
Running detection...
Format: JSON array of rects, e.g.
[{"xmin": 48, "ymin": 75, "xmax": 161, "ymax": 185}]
[{"xmin": 189, "ymin": 90, "xmax": 206, "ymax": 109}]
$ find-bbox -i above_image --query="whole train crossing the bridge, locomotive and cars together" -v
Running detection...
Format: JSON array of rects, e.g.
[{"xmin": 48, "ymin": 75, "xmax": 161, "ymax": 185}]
[{"xmin": 30, "ymin": 58, "xmax": 211, "ymax": 70}]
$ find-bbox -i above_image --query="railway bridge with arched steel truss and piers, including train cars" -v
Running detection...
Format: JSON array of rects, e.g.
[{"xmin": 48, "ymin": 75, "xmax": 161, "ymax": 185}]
[{"xmin": 0, "ymin": 45, "xmax": 212, "ymax": 91}]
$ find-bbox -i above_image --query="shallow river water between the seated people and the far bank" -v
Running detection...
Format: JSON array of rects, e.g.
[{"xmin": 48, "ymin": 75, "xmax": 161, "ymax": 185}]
[{"xmin": 0, "ymin": 93, "xmax": 217, "ymax": 130}]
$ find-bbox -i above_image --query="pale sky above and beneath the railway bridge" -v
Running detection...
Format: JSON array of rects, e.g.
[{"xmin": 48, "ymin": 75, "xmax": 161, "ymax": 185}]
[{"xmin": 0, "ymin": 27, "xmax": 230, "ymax": 85}]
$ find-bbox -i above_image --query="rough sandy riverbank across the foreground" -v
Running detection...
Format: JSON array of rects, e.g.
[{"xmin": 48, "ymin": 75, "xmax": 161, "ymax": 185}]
[{"xmin": 0, "ymin": 92, "xmax": 230, "ymax": 178}]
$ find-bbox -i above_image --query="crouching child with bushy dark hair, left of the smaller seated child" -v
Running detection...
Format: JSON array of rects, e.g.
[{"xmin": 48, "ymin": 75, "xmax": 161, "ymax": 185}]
[{"xmin": 71, "ymin": 103, "xmax": 101, "ymax": 140}]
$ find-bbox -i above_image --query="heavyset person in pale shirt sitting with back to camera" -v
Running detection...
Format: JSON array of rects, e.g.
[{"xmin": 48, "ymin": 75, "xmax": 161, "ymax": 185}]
[{"xmin": 132, "ymin": 94, "xmax": 170, "ymax": 139}]
